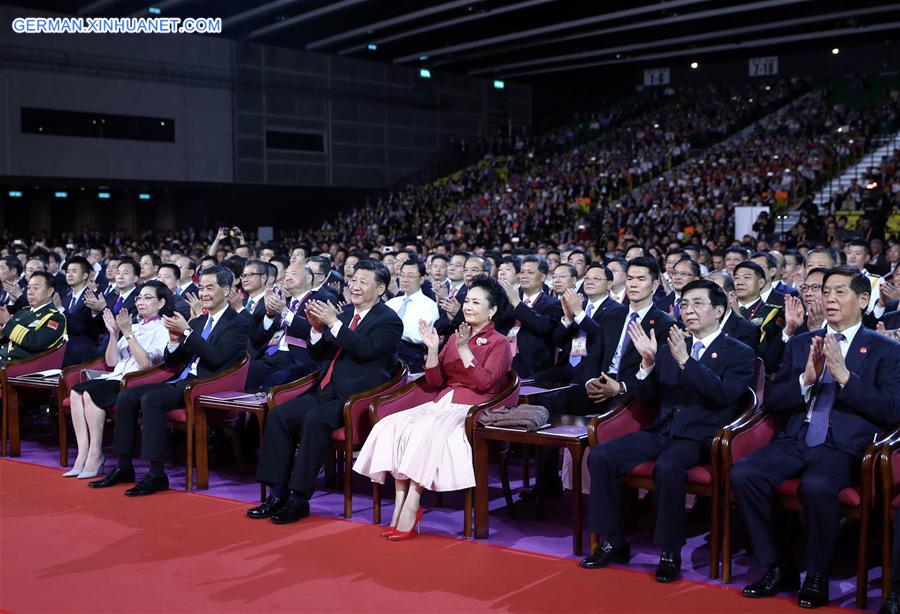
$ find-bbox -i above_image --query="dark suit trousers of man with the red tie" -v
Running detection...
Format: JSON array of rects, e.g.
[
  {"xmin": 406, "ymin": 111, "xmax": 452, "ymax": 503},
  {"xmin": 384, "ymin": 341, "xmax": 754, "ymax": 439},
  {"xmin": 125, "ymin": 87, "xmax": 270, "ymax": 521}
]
[{"xmin": 256, "ymin": 386, "xmax": 349, "ymax": 499}]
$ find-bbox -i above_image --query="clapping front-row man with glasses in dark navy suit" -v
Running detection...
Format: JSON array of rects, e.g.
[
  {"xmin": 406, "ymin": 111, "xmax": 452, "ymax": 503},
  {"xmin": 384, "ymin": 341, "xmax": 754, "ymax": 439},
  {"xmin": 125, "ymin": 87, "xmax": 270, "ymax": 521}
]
[{"xmin": 581, "ymin": 279, "xmax": 754, "ymax": 582}]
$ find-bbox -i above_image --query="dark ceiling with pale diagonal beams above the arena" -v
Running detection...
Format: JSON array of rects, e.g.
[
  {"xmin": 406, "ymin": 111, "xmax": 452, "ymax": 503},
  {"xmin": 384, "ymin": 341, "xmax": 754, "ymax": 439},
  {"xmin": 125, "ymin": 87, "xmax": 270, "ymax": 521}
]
[{"xmin": 10, "ymin": 0, "xmax": 900, "ymax": 82}]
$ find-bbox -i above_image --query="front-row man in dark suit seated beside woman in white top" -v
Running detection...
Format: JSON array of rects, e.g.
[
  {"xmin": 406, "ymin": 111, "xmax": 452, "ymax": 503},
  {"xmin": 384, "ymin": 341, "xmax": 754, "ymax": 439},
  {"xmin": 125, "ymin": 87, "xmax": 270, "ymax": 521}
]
[{"xmin": 90, "ymin": 267, "xmax": 249, "ymax": 497}]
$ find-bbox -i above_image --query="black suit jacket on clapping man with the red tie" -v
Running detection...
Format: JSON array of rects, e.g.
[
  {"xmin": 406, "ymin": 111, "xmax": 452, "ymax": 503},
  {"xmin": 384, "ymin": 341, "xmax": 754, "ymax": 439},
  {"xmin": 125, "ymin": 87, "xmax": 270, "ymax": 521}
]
[{"xmin": 312, "ymin": 301, "xmax": 403, "ymax": 399}]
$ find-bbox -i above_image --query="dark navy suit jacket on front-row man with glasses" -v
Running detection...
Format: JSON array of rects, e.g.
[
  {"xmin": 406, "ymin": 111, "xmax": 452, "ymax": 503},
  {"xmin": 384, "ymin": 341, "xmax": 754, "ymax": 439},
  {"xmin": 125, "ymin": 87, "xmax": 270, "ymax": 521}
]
[{"xmin": 637, "ymin": 333, "xmax": 755, "ymax": 444}]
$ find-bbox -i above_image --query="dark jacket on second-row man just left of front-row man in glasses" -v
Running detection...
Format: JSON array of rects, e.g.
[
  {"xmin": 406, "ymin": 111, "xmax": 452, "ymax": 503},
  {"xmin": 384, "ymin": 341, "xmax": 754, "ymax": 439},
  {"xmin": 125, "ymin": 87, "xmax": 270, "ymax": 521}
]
[{"xmin": 579, "ymin": 306, "xmax": 675, "ymax": 390}]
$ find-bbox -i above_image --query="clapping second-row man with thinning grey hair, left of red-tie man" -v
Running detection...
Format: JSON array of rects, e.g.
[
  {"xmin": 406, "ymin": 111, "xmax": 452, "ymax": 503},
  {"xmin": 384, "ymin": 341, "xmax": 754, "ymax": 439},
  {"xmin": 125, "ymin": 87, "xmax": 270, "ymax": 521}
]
[{"xmin": 247, "ymin": 262, "xmax": 337, "ymax": 392}]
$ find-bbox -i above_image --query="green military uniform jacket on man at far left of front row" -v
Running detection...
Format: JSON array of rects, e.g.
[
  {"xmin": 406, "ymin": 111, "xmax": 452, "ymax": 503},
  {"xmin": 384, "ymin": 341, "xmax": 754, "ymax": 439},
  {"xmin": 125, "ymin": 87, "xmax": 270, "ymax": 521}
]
[{"xmin": 0, "ymin": 303, "xmax": 66, "ymax": 365}]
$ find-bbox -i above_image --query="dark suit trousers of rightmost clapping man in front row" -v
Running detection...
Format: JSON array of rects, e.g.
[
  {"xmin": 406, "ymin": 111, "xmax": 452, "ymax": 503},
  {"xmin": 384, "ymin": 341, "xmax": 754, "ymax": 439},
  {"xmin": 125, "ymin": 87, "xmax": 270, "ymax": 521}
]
[{"xmin": 731, "ymin": 438, "xmax": 859, "ymax": 573}]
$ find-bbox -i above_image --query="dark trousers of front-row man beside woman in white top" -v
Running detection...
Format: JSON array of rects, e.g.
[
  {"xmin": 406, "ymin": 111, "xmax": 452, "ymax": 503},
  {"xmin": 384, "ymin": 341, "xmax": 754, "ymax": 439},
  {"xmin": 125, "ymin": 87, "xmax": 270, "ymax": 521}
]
[{"xmin": 113, "ymin": 379, "xmax": 190, "ymax": 463}]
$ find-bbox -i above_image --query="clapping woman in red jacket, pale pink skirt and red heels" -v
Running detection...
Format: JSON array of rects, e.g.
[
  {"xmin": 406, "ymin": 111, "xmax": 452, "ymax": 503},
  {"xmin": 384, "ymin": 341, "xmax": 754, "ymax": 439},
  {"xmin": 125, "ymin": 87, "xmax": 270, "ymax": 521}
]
[{"xmin": 353, "ymin": 276, "xmax": 512, "ymax": 540}]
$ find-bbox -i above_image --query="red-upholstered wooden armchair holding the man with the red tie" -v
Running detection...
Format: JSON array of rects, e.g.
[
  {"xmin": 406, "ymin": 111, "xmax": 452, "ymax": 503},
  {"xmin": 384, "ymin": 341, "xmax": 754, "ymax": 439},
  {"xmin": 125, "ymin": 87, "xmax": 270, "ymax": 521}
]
[{"xmin": 328, "ymin": 360, "xmax": 409, "ymax": 518}]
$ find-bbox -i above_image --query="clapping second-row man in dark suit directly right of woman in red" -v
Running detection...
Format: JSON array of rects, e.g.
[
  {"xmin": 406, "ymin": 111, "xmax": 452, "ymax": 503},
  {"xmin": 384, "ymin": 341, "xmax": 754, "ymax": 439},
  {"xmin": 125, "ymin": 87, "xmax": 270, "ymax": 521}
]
[{"xmin": 501, "ymin": 255, "xmax": 563, "ymax": 378}]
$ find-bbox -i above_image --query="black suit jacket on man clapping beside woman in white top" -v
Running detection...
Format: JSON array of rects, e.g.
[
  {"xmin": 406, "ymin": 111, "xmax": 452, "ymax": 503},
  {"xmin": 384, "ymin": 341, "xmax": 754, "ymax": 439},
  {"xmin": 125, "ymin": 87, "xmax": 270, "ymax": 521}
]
[{"xmin": 164, "ymin": 307, "xmax": 250, "ymax": 378}]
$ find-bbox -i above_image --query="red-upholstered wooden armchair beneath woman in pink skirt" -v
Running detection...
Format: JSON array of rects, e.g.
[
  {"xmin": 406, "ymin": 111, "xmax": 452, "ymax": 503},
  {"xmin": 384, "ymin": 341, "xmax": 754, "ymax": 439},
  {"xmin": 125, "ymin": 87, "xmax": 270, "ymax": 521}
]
[{"xmin": 369, "ymin": 370, "xmax": 519, "ymax": 537}]
